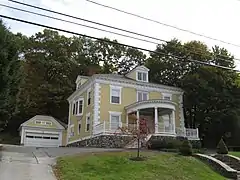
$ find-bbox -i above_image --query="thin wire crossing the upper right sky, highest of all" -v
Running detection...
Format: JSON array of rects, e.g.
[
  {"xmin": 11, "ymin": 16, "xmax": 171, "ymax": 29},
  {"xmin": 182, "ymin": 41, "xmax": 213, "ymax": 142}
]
[{"xmin": 84, "ymin": 0, "xmax": 240, "ymax": 47}]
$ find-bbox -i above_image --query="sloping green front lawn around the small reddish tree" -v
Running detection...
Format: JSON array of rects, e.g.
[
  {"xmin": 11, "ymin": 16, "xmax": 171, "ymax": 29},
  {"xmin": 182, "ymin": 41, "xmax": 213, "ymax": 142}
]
[{"xmin": 55, "ymin": 152, "xmax": 225, "ymax": 180}]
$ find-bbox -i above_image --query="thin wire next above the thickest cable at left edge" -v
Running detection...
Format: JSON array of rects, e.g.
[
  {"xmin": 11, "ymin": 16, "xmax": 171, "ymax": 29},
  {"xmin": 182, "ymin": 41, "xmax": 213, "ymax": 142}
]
[{"xmin": 0, "ymin": 3, "xmax": 159, "ymax": 45}]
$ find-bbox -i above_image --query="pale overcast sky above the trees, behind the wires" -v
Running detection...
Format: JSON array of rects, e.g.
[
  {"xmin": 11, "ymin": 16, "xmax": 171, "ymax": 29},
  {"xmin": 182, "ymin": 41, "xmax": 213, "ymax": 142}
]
[{"xmin": 0, "ymin": 0, "xmax": 240, "ymax": 70}]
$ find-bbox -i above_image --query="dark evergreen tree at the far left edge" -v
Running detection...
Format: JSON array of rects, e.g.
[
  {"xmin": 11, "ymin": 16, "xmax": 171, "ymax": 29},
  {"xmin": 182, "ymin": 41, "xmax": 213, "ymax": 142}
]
[{"xmin": 0, "ymin": 20, "xmax": 23, "ymax": 131}]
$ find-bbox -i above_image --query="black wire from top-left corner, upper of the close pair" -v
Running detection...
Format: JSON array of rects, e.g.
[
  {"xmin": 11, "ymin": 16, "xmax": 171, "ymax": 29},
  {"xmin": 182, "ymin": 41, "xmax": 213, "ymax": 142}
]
[{"xmin": 9, "ymin": 0, "xmax": 240, "ymax": 62}]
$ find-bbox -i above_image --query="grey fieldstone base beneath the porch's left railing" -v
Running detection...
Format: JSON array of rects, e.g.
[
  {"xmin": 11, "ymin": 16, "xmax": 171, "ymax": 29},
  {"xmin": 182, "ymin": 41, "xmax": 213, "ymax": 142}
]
[{"xmin": 67, "ymin": 135, "xmax": 133, "ymax": 148}]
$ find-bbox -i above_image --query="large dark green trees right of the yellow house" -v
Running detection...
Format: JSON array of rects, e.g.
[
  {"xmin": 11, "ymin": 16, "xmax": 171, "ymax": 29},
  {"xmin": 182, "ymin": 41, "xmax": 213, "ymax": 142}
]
[{"xmin": 146, "ymin": 39, "xmax": 240, "ymax": 145}]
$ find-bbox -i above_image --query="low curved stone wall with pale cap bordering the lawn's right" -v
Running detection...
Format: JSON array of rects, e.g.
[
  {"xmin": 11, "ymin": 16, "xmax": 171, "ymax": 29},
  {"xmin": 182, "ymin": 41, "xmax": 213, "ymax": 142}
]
[{"xmin": 194, "ymin": 154, "xmax": 237, "ymax": 179}]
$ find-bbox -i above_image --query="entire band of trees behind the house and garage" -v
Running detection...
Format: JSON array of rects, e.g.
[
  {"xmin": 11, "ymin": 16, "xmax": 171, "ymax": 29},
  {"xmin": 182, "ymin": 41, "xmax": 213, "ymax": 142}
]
[{"xmin": 0, "ymin": 21, "xmax": 240, "ymax": 147}]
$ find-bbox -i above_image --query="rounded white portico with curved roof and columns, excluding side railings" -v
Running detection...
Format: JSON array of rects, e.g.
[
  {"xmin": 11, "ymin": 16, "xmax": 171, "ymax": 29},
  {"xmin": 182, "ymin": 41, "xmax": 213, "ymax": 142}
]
[{"xmin": 125, "ymin": 100, "xmax": 176, "ymax": 135}]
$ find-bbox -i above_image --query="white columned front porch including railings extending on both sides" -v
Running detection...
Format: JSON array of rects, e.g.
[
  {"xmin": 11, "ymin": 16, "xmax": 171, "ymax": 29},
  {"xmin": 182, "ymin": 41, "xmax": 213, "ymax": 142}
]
[{"xmin": 93, "ymin": 99, "xmax": 199, "ymax": 139}]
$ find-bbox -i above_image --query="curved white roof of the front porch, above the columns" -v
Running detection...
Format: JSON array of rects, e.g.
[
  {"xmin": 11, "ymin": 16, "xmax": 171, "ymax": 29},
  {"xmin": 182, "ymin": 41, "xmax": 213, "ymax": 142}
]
[{"xmin": 124, "ymin": 99, "xmax": 177, "ymax": 113}]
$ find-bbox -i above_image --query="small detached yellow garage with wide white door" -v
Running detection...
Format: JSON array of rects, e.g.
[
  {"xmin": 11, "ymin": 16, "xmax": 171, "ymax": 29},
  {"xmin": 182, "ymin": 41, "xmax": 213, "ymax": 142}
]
[{"xmin": 20, "ymin": 115, "xmax": 66, "ymax": 147}]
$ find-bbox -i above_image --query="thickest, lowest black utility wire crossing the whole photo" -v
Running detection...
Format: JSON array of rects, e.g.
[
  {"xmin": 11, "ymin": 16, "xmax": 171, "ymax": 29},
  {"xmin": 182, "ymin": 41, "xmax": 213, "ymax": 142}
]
[{"xmin": 0, "ymin": 14, "xmax": 240, "ymax": 72}]
